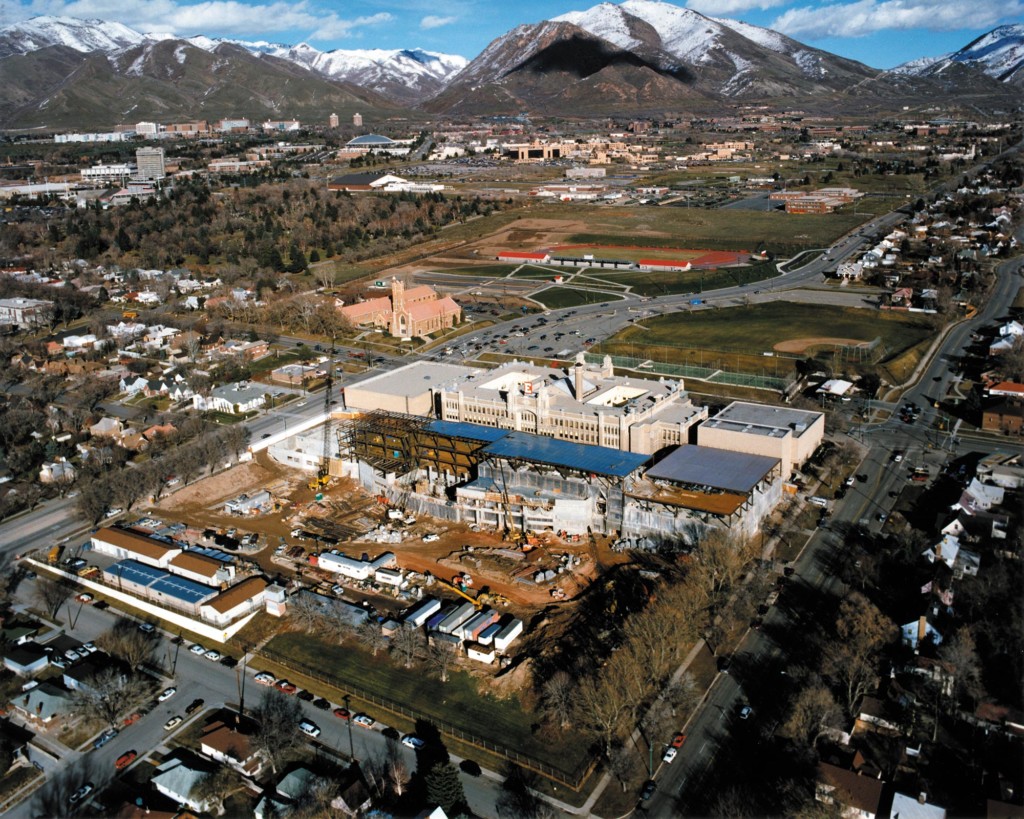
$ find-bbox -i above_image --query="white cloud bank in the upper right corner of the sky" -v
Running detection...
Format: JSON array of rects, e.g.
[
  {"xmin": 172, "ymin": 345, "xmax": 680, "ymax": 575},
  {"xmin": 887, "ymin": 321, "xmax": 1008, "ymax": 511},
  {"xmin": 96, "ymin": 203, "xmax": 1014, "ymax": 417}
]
[{"xmin": 769, "ymin": 0, "xmax": 1024, "ymax": 39}]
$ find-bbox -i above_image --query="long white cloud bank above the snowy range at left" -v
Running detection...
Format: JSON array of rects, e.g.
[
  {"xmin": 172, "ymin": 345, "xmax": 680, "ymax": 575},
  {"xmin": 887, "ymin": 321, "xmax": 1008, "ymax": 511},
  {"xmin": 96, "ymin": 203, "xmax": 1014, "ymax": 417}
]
[{"xmin": 19, "ymin": 0, "xmax": 394, "ymax": 39}]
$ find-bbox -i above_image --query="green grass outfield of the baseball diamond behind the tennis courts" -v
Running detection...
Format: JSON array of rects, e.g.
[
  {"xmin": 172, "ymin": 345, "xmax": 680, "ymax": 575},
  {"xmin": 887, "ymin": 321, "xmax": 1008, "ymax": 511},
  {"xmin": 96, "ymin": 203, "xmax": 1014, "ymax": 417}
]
[{"xmin": 601, "ymin": 302, "xmax": 935, "ymax": 356}]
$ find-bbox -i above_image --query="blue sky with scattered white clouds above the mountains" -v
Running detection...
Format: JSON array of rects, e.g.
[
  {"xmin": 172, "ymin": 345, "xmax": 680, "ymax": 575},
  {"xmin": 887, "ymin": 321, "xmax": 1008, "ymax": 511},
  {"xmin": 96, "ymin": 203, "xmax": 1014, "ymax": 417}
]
[{"xmin": 6, "ymin": 0, "xmax": 1024, "ymax": 69}]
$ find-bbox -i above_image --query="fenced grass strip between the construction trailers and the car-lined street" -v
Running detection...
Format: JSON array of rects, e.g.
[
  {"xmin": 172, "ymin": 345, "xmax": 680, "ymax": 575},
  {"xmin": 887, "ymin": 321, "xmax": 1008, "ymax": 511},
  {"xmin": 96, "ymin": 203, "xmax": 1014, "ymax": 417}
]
[{"xmin": 260, "ymin": 634, "xmax": 587, "ymax": 772}]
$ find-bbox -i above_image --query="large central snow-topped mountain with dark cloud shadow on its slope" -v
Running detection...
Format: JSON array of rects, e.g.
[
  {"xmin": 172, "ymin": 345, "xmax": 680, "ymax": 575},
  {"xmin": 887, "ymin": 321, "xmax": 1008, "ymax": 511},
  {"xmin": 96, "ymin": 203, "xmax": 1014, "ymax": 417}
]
[{"xmin": 429, "ymin": 0, "xmax": 878, "ymax": 113}]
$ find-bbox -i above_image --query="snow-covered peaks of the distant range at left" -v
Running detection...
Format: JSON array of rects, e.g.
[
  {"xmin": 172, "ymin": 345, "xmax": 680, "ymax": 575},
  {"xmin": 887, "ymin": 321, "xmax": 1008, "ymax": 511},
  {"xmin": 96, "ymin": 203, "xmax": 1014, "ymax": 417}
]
[{"xmin": 0, "ymin": 16, "xmax": 467, "ymax": 104}]
